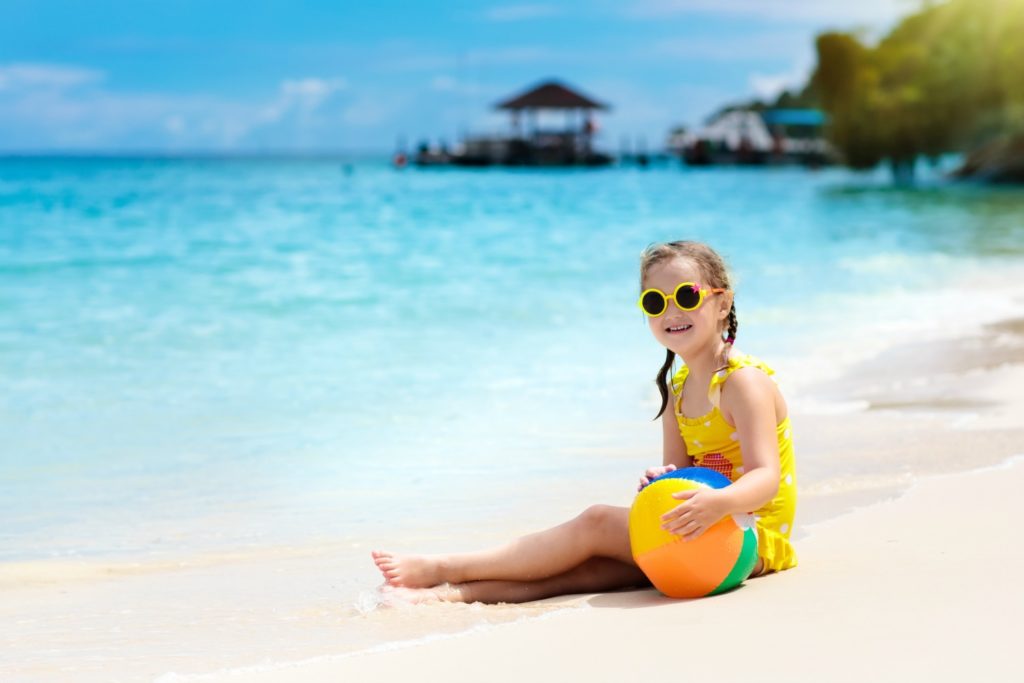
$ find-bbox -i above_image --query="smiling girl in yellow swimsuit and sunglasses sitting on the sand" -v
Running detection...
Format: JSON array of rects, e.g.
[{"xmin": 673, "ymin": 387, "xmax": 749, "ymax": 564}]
[{"xmin": 373, "ymin": 242, "xmax": 797, "ymax": 603}]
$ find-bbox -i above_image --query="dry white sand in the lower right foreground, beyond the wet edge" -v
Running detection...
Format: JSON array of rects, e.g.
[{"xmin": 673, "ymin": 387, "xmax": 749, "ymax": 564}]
[{"xmin": 210, "ymin": 458, "xmax": 1024, "ymax": 683}]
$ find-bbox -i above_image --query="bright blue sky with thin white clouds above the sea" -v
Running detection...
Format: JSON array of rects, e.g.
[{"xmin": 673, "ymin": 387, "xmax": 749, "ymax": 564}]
[{"xmin": 0, "ymin": 0, "xmax": 918, "ymax": 153}]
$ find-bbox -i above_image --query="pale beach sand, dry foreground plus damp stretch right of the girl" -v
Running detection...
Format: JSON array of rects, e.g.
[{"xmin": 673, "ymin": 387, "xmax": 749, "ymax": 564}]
[{"xmin": 160, "ymin": 321, "xmax": 1024, "ymax": 683}]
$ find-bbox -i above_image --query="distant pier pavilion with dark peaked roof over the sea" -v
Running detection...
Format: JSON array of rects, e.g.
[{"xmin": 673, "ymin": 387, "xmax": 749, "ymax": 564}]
[{"xmin": 414, "ymin": 81, "xmax": 614, "ymax": 167}]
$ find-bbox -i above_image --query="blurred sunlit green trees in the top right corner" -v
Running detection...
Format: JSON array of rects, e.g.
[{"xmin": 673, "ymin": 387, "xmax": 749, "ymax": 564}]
[{"xmin": 808, "ymin": 0, "xmax": 1024, "ymax": 179}]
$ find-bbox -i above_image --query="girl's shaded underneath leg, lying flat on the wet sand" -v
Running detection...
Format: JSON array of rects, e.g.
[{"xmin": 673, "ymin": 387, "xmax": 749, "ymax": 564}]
[{"xmin": 390, "ymin": 557, "xmax": 650, "ymax": 604}]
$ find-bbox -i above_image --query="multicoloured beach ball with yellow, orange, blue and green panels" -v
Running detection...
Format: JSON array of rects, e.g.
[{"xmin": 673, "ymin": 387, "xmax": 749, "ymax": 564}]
[{"xmin": 630, "ymin": 467, "xmax": 758, "ymax": 598}]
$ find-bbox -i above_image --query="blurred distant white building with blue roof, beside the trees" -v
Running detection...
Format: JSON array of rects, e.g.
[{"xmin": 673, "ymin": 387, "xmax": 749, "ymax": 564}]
[{"xmin": 673, "ymin": 110, "xmax": 835, "ymax": 166}]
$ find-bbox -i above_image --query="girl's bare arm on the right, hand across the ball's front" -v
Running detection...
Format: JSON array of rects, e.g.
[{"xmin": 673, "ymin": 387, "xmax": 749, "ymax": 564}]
[{"xmin": 662, "ymin": 368, "xmax": 785, "ymax": 539}]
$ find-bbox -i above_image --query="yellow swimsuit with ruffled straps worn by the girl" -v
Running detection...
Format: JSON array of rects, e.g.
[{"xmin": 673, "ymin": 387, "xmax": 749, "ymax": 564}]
[{"xmin": 672, "ymin": 353, "xmax": 797, "ymax": 571}]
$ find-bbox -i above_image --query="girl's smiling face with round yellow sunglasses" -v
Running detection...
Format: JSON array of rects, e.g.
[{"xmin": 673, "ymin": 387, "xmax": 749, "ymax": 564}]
[{"xmin": 643, "ymin": 257, "xmax": 732, "ymax": 358}]
